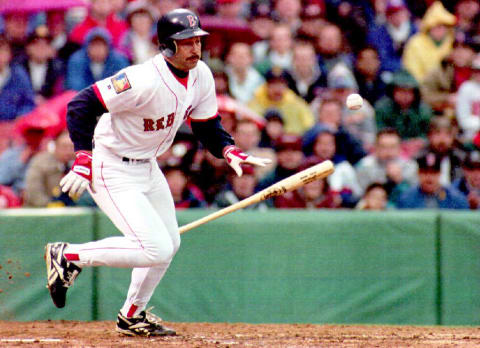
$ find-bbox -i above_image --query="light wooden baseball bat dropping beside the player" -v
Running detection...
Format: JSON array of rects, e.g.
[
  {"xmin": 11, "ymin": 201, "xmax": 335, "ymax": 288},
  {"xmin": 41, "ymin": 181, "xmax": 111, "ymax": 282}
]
[{"xmin": 179, "ymin": 160, "xmax": 334, "ymax": 233}]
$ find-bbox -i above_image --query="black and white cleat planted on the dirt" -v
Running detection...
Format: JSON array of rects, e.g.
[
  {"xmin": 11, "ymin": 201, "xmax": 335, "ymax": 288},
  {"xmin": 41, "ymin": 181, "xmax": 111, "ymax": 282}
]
[{"xmin": 115, "ymin": 310, "xmax": 177, "ymax": 337}]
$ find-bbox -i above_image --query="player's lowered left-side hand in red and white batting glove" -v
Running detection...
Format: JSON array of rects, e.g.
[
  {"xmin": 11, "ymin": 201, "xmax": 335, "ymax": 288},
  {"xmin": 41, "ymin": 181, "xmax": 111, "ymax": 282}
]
[{"xmin": 60, "ymin": 151, "xmax": 92, "ymax": 197}]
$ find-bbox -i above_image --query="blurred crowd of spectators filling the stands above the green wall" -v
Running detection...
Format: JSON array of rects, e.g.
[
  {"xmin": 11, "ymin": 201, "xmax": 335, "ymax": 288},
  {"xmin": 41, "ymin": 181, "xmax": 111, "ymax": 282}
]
[{"xmin": 0, "ymin": 0, "xmax": 480, "ymax": 210}]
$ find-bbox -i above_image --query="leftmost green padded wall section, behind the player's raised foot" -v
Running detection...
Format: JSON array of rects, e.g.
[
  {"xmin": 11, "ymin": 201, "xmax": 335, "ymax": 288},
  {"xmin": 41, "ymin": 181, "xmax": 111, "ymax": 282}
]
[{"xmin": 0, "ymin": 209, "xmax": 94, "ymax": 321}]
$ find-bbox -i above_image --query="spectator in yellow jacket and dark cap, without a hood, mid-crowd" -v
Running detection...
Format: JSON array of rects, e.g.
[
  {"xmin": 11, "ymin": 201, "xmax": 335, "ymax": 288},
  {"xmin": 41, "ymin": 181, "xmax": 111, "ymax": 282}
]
[{"xmin": 248, "ymin": 68, "xmax": 315, "ymax": 136}]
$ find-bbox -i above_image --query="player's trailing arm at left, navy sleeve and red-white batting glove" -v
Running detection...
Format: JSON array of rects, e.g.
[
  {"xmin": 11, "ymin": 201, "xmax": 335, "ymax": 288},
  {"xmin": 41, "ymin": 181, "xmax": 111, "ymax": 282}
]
[{"xmin": 60, "ymin": 85, "xmax": 108, "ymax": 197}]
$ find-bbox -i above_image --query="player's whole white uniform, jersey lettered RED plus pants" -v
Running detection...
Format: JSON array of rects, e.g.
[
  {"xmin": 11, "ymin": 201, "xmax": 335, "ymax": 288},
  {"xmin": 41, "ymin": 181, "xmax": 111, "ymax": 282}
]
[{"xmin": 65, "ymin": 54, "xmax": 217, "ymax": 315}]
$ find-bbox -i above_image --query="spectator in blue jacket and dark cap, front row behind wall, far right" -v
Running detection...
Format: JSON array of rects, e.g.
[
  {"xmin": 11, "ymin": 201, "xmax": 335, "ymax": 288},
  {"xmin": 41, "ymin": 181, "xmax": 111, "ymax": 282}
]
[{"xmin": 397, "ymin": 153, "xmax": 469, "ymax": 209}]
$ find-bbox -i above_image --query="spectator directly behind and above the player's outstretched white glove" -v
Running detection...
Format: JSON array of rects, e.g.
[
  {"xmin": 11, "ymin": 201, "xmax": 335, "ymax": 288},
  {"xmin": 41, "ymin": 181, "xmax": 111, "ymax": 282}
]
[{"xmin": 232, "ymin": 119, "xmax": 276, "ymax": 179}]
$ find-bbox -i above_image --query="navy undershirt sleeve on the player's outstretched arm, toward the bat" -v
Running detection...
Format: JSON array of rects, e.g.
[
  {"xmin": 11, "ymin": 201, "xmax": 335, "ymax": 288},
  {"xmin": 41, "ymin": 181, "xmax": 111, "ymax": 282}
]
[{"xmin": 191, "ymin": 115, "xmax": 235, "ymax": 158}]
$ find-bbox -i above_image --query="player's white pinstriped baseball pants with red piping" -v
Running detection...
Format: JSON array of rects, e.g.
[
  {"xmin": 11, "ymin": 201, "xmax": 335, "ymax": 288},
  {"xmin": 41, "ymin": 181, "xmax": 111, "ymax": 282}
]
[{"xmin": 65, "ymin": 149, "xmax": 180, "ymax": 315}]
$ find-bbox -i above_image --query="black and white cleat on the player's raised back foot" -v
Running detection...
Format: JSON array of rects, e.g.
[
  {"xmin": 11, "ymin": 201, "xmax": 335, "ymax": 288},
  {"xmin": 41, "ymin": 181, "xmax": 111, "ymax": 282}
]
[{"xmin": 45, "ymin": 242, "xmax": 82, "ymax": 308}]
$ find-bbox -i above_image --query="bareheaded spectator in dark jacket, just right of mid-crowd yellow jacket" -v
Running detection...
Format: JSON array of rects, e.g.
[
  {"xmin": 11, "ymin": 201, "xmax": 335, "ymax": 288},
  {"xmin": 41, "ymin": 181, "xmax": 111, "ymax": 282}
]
[{"xmin": 290, "ymin": 41, "xmax": 327, "ymax": 103}]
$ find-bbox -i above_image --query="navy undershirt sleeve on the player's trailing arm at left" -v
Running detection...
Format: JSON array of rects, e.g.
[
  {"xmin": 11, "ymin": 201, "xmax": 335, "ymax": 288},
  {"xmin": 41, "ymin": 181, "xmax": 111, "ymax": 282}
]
[{"xmin": 67, "ymin": 86, "xmax": 108, "ymax": 151}]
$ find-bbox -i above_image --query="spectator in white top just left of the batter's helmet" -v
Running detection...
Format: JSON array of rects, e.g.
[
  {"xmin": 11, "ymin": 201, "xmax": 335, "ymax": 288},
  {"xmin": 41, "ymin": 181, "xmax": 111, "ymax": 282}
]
[{"xmin": 119, "ymin": 0, "xmax": 158, "ymax": 64}]
